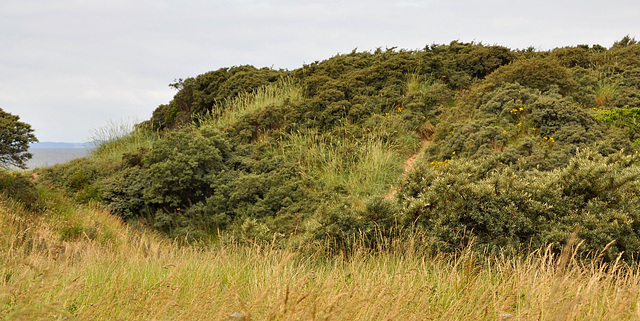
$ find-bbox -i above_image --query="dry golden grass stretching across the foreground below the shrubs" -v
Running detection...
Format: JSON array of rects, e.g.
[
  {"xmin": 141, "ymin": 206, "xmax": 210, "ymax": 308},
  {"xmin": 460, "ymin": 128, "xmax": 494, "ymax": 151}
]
[{"xmin": 0, "ymin": 191, "xmax": 640, "ymax": 320}]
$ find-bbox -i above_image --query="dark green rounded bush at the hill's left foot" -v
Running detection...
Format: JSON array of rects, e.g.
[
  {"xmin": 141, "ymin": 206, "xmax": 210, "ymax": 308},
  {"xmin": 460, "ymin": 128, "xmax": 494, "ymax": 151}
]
[{"xmin": 100, "ymin": 126, "xmax": 310, "ymax": 236}]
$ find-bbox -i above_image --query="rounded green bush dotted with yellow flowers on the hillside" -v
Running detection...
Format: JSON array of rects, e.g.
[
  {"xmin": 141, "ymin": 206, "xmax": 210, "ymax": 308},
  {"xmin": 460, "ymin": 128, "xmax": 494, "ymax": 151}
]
[{"xmin": 429, "ymin": 84, "xmax": 630, "ymax": 170}]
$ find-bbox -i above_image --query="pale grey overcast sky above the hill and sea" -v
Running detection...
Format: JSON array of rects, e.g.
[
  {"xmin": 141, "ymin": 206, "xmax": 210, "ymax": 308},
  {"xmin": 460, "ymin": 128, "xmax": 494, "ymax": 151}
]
[{"xmin": 0, "ymin": 0, "xmax": 640, "ymax": 142}]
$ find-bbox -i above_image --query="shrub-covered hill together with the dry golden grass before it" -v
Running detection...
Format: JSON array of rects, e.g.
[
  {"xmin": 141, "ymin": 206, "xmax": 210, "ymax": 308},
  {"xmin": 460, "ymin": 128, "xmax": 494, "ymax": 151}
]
[{"xmin": 0, "ymin": 37, "xmax": 640, "ymax": 320}]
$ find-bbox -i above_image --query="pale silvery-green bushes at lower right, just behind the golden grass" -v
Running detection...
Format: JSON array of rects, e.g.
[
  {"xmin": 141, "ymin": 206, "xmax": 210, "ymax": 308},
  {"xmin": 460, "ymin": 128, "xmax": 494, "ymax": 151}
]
[{"xmin": 399, "ymin": 151, "xmax": 640, "ymax": 260}]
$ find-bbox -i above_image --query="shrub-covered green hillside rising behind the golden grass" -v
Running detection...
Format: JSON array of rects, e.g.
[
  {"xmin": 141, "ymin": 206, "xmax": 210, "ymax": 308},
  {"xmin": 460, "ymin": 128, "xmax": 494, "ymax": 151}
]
[{"xmin": 39, "ymin": 37, "xmax": 640, "ymax": 260}]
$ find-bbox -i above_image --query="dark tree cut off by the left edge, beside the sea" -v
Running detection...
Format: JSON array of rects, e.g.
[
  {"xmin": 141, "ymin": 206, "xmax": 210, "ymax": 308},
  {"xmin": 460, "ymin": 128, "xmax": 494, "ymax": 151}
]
[{"xmin": 0, "ymin": 108, "xmax": 38, "ymax": 168}]
